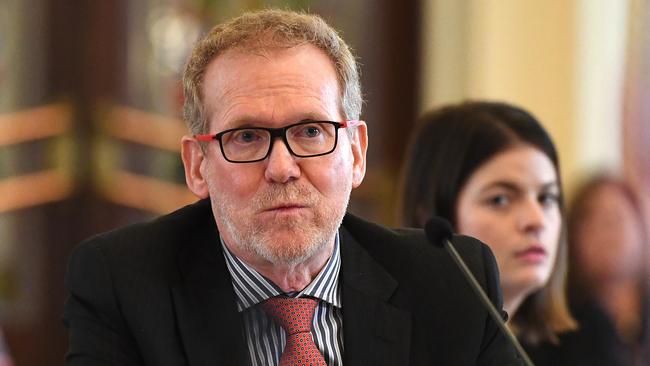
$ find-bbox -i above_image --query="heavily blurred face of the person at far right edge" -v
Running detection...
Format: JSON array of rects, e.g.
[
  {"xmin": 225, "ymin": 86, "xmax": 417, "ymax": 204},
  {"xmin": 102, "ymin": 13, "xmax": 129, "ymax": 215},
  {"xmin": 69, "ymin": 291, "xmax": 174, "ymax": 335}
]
[{"xmin": 573, "ymin": 184, "xmax": 643, "ymax": 283}]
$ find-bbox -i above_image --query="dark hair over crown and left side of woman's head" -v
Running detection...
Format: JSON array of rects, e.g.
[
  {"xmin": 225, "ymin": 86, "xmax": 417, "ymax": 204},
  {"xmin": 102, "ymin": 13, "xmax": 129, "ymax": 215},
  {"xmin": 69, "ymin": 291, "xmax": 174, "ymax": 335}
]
[{"xmin": 402, "ymin": 102, "xmax": 562, "ymax": 227}]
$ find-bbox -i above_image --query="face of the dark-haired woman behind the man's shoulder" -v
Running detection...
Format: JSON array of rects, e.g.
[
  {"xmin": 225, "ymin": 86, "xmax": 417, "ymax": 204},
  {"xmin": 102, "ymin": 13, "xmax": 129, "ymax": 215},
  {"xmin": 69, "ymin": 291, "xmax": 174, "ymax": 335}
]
[{"xmin": 456, "ymin": 145, "xmax": 562, "ymax": 306}]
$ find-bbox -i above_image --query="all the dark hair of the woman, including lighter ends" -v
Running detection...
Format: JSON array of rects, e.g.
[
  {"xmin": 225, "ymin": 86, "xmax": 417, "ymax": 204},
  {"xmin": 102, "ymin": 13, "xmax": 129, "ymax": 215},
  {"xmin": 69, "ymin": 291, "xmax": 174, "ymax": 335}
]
[{"xmin": 401, "ymin": 101, "xmax": 576, "ymax": 343}]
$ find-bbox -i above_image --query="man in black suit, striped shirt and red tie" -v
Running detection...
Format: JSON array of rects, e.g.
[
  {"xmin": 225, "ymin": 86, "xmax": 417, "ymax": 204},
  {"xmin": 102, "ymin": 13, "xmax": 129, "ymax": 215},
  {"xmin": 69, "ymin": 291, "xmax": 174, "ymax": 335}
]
[{"xmin": 64, "ymin": 10, "xmax": 519, "ymax": 366}]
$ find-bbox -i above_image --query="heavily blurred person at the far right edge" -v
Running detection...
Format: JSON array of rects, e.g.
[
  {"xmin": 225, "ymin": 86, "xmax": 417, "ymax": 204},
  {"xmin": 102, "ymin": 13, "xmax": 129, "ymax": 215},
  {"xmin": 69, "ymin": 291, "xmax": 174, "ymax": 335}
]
[{"xmin": 528, "ymin": 175, "xmax": 650, "ymax": 366}]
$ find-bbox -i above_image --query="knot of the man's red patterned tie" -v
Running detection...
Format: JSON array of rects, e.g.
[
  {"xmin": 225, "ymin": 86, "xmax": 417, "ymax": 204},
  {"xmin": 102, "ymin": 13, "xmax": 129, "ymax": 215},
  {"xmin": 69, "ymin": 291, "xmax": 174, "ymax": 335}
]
[{"xmin": 262, "ymin": 297, "xmax": 318, "ymax": 335}]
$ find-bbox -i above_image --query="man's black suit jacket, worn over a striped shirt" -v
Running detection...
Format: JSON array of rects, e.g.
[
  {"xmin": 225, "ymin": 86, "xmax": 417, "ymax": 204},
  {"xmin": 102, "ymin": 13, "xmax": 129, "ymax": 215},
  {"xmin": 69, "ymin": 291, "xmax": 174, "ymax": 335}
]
[{"xmin": 63, "ymin": 200, "xmax": 520, "ymax": 366}]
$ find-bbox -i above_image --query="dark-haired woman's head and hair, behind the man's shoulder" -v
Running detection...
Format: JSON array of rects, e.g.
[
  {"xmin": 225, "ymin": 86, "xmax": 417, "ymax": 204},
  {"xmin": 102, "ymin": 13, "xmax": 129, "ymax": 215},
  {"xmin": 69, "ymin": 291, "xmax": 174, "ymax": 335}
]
[{"xmin": 401, "ymin": 101, "xmax": 576, "ymax": 348}]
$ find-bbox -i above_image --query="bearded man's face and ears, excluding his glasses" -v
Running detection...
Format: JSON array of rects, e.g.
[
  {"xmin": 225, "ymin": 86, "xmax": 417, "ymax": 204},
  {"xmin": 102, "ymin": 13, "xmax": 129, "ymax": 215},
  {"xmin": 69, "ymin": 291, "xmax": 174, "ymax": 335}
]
[{"xmin": 183, "ymin": 45, "xmax": 367, "ymax": 265}]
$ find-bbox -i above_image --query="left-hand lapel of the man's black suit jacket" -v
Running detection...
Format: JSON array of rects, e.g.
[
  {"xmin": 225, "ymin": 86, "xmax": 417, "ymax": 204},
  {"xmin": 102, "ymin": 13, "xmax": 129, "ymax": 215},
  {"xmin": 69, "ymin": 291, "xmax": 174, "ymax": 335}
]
[{"xmin": 172, "ymin": 217, "xmax": 248, "ymax": 366}]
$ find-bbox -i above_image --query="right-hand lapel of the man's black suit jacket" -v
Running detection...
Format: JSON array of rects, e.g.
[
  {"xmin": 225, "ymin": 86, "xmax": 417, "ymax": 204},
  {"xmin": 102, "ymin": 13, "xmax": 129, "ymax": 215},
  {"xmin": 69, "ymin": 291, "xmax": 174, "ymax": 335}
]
[{"xmin": 340, "ymin": 227, "xmax": 411, "ymax": 365}]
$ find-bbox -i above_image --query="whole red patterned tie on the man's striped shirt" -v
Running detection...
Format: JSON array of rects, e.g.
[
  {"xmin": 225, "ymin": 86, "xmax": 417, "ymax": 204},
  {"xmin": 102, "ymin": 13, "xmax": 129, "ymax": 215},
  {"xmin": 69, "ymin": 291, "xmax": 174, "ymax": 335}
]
[{"xmin": 262, "ymin": 297, "xmax": 327, "ymax": 366}]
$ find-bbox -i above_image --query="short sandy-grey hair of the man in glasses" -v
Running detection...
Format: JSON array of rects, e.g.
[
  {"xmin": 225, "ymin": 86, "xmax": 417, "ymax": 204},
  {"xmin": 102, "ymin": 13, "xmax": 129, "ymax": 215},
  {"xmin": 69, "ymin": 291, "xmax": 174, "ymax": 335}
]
[{"xmin": 183, "ymin": 9, "xmax": 363, "ymax": 134}]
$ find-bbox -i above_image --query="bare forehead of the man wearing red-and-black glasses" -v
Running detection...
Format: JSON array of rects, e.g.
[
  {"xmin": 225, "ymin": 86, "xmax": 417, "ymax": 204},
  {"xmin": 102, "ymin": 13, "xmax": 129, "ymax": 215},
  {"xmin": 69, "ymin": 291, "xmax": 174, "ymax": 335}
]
[{"xmin": 203, "ymin": 45, "xmax": 341, "ymax": 129}]
